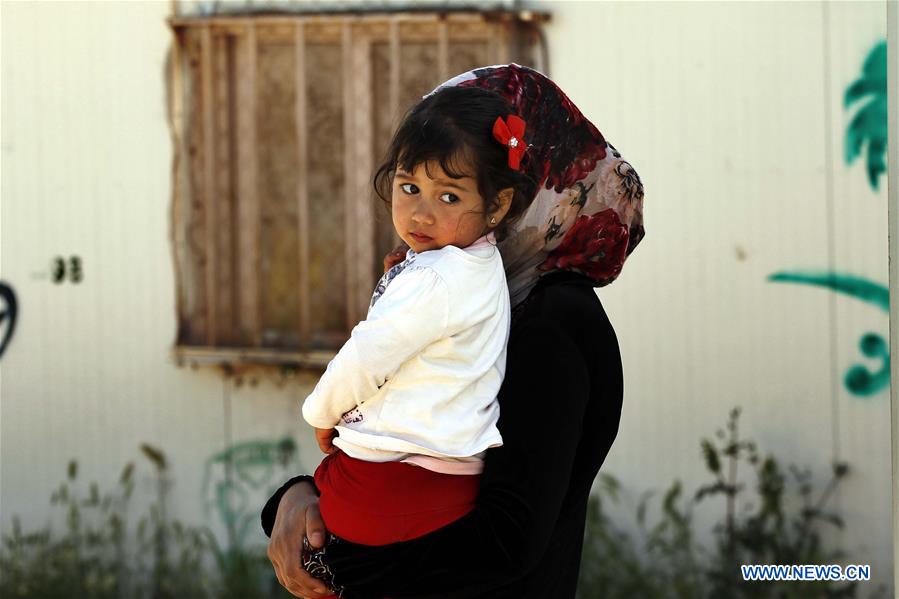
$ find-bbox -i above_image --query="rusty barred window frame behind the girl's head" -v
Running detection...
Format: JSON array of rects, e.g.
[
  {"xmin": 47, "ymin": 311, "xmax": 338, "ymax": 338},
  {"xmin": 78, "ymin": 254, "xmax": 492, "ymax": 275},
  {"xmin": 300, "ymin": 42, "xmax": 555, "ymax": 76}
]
[{"xmin": 169, "ymin": 11, "xmax": 548, "ymax": 368}]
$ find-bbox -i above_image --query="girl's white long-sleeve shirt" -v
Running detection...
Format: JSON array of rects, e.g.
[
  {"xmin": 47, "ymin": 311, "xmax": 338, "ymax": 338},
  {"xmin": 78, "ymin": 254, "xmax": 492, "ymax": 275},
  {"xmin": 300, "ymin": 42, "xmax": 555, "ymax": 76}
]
[{"xmin": 303, "ymin": 236, "xmax": 510, "ymax": 474}]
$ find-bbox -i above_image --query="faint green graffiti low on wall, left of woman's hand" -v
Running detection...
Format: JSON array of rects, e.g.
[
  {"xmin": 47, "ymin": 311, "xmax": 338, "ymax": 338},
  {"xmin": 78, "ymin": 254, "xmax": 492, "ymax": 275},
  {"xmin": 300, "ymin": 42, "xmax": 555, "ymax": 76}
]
[{"xmin": 202, "ymin": 437, "xmax": 298, "ymax": 547}]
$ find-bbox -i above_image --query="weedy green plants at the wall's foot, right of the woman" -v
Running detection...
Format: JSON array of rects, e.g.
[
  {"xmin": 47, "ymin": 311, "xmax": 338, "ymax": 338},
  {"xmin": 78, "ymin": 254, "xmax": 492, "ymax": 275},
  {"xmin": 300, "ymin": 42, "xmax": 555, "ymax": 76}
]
[{"xmin": 578, "ymin": 408, "xmax": 876, "ymax": 599}]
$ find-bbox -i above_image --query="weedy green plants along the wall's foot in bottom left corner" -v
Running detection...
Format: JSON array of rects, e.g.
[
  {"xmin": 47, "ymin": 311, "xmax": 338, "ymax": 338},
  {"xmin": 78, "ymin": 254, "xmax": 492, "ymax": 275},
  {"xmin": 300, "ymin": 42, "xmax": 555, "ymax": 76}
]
[{"xmin": 0, "ymin": 444, "xmax": 291, "ymax": 599}]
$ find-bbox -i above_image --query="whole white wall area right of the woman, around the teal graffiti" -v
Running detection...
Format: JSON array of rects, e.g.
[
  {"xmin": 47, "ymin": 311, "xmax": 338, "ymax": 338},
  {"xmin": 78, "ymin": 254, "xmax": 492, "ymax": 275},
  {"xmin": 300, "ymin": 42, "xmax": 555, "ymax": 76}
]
[{"xmin": 540, "ymin": 2, "xmax": 892, "ymax": 596}]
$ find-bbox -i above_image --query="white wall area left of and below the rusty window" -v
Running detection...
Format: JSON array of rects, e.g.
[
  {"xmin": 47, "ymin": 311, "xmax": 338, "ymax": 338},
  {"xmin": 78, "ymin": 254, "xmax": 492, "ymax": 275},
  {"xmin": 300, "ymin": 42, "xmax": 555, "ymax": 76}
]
[{"xmin": 0, "ymin": 2, "xmax": 317, "ymax": 552}]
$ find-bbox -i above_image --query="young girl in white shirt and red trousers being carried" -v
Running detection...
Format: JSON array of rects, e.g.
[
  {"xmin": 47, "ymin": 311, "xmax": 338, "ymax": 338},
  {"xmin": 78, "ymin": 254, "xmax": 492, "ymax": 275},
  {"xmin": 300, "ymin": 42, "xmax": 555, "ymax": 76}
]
[{"xmin": 303, "ymin": 87, "xmax": 536, "ymax": 576}]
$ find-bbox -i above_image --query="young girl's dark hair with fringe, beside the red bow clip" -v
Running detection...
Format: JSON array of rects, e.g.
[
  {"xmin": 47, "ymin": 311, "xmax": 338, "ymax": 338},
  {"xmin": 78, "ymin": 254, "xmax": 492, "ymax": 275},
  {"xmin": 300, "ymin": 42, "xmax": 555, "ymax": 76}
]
[{"xmin": 374, "ymin": 87, "xmax": 537, "ymax": 240}]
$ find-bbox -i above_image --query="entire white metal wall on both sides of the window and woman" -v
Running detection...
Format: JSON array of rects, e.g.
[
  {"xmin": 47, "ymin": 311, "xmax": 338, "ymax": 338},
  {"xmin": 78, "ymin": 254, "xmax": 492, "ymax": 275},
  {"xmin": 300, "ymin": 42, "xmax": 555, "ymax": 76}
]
[{"xmin": 0, "ymin": 2, "xmax": 892, "ymax": 596}]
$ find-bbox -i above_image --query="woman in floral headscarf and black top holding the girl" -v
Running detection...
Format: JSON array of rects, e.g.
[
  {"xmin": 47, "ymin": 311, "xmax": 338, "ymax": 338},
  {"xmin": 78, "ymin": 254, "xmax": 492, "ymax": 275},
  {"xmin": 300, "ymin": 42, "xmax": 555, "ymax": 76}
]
[{"xmin": 262, "ymin": 64, "xmax": 643, "ymax": 599}]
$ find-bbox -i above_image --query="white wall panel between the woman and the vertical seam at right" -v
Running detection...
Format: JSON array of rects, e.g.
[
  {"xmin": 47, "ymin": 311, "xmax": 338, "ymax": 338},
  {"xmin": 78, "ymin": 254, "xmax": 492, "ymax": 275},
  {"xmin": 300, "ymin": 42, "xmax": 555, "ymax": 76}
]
[{"xmin": 536, "ymin": 3, "xmax": 830, "ymax": 484}]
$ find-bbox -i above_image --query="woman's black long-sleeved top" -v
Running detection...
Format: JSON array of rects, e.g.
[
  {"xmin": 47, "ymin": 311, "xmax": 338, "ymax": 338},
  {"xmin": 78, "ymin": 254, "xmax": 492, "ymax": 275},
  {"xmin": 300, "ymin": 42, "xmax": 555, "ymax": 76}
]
[{"xmin": 262, "ymin": 272, "xmax": 624, "ymax": 599}]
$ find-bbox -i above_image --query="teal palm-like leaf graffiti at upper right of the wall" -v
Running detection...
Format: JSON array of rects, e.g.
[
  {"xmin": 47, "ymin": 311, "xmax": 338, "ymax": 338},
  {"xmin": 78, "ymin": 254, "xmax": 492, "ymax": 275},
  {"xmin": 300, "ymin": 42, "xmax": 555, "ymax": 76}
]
[{"xmin": 843, "ymin": 41, "xmax": 887, "ymax": 191}]
